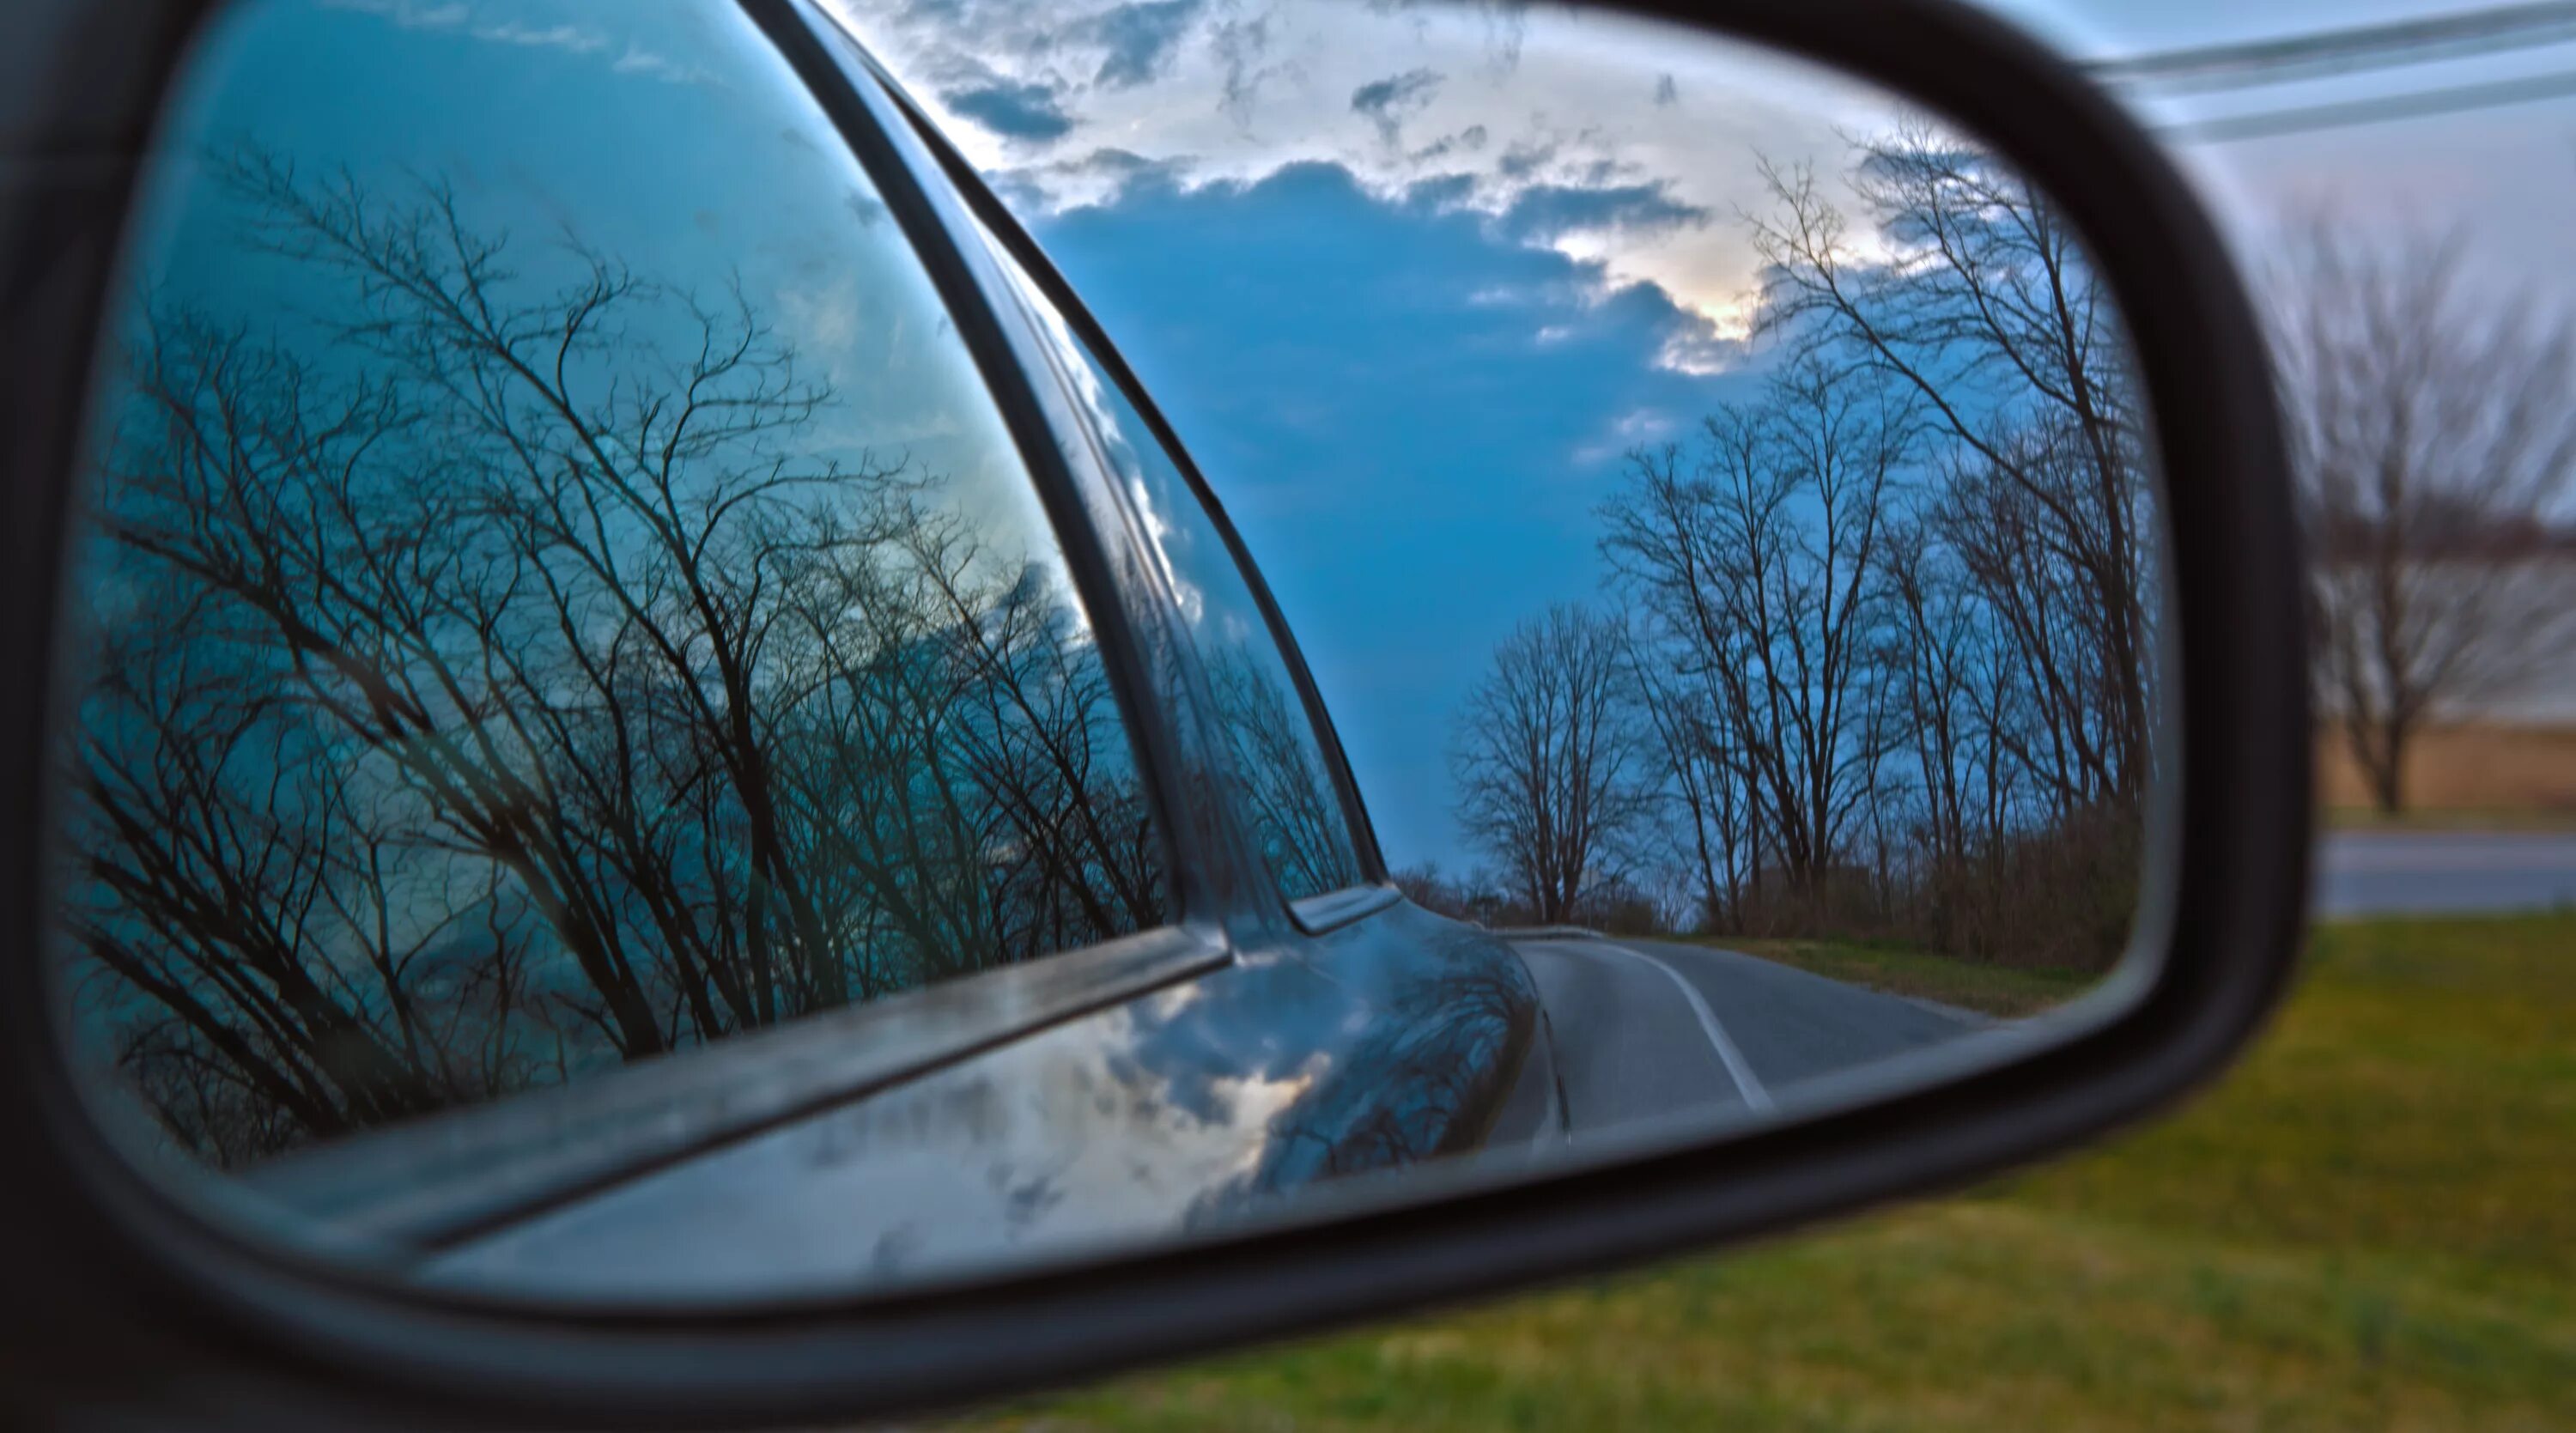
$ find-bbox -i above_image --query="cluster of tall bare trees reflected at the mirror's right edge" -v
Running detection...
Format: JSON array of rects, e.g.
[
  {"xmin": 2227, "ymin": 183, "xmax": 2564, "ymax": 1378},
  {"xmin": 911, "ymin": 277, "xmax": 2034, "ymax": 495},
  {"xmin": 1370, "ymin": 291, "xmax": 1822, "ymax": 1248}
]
[{"xmin": 1546, "ymin": 126, "xmax": 2161, "ymax": 964}]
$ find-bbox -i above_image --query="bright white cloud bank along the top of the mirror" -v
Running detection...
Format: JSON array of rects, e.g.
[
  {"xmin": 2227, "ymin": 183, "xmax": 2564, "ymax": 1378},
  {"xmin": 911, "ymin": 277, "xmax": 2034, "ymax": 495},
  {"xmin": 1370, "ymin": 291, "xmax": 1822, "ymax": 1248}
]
[{"xmin": 827, "ymin": 0, "xmax": 1899, "ymax": 348}]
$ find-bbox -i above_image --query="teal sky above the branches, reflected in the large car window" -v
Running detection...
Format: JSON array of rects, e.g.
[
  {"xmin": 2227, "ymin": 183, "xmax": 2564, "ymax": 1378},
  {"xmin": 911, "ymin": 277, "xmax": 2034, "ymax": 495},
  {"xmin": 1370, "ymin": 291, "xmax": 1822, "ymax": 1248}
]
[{"xmin": 142, "ymin": 0, "xmax": 1069, "ymax": 577}]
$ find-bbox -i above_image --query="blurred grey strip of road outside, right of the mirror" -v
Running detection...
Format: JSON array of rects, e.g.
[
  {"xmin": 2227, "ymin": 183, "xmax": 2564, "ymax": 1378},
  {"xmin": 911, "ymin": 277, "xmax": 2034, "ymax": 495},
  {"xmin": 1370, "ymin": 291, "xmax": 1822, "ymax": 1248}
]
[{"xmin": 2316, "ymin": 830, "xmax": 2576, "ymax": 918}]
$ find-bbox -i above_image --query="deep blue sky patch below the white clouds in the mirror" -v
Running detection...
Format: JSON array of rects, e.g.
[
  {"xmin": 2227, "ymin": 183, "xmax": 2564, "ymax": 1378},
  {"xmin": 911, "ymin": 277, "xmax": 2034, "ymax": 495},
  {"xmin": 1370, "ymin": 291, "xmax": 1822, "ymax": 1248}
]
[{"xmin": 1038, "ymin": 162, "xmax": 1734, "ymax": 864}]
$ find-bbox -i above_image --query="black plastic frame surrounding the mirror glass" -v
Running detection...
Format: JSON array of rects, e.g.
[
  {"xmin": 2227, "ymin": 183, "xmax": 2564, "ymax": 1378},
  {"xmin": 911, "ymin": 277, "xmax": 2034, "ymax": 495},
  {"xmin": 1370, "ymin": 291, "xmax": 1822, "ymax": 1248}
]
[{"xmin": 0, "ymin": 0, "xmax": 2311, "ymax": 1428}]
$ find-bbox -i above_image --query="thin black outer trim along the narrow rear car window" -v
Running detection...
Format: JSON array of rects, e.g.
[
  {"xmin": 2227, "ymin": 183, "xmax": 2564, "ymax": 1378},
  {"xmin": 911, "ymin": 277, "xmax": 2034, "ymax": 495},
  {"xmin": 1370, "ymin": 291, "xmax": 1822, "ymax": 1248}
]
[{"xmin": 855, "ymin": 52, "xmax": 1391, "ymax": 917}]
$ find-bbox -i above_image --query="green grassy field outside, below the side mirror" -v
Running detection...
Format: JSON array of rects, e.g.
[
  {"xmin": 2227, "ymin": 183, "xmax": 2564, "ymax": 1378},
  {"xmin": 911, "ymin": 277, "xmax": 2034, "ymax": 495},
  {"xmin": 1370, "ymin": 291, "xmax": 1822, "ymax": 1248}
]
[{"xmin": 958, "ymin": 918, "xmax": 2576, "ymax": 1433}]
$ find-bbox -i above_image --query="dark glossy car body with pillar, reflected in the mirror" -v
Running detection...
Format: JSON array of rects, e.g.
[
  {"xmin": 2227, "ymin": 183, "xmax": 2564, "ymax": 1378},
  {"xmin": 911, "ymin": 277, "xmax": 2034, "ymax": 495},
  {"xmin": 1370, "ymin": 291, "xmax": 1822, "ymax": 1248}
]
[{"xmin": 211, "ymin": 3, "xmax": 1564, "ymax": 1304}]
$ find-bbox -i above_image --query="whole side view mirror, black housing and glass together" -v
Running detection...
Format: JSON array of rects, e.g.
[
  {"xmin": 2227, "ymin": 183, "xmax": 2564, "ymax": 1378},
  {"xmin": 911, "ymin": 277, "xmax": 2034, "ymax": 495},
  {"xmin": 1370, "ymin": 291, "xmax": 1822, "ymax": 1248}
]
[{"xmin": 0, "ymin": 0, "xmax": 2311, "ymax": 1428}]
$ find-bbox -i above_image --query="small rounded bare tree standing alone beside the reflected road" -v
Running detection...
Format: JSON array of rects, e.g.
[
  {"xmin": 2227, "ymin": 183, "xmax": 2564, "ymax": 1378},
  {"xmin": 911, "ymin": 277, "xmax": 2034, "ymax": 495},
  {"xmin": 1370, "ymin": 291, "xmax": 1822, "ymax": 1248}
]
[{"xmin": 1450, "ymin": 603, "xmax": 1651, "ymax": 923}]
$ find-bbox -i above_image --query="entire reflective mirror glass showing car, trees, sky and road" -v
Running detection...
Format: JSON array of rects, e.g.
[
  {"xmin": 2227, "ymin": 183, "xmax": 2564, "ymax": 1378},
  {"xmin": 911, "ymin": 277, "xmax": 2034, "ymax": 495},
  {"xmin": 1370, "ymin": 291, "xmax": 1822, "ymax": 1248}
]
[{"xmin": 52, "ymin": 0, "xmax": 2174, "ymax": 1307}]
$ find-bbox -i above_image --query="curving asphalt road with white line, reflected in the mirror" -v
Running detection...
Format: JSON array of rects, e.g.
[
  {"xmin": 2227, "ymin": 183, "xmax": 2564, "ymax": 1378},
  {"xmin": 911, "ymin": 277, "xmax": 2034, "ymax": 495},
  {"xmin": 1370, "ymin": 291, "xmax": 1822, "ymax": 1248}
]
[{"xmin": 1512, "ymin": 938, "xmax": 1984, "ymax": 1137}]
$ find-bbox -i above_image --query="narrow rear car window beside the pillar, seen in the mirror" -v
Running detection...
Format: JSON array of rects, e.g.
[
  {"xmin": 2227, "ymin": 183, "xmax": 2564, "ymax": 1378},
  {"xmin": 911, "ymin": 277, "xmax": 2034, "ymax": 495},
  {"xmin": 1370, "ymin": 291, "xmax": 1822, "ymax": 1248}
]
[{"xmin": 984, "ymin": 232, "xmax": 1363, "ymax": 900}]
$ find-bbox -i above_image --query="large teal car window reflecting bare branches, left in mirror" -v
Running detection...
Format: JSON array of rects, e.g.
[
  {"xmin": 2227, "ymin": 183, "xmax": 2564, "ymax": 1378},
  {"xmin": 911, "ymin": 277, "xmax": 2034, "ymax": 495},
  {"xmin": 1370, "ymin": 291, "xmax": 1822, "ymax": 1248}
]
[{"xmin": 59, "ymin": 0, "xmax": 1167, "ymax": 1165}]
